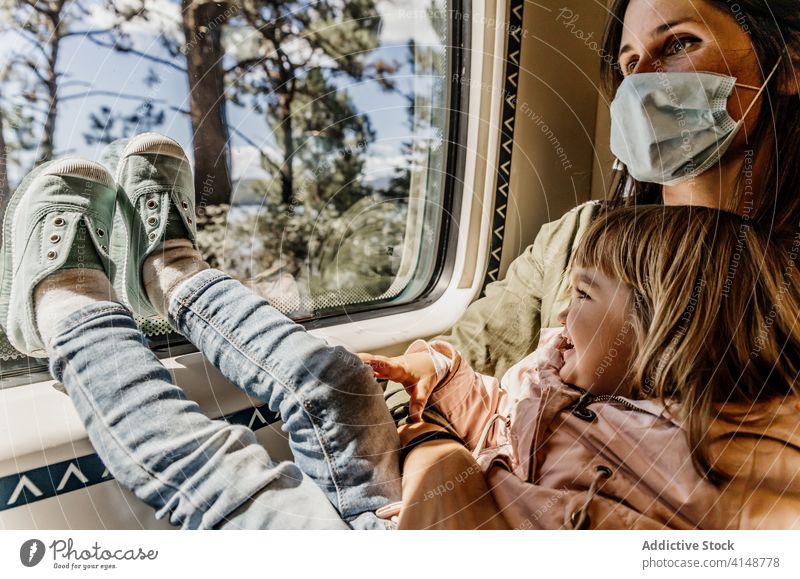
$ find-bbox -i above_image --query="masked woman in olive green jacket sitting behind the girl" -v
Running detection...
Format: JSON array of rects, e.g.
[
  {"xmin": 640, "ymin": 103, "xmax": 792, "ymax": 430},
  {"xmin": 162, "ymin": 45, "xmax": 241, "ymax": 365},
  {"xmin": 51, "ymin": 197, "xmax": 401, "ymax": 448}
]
[{"xmin": 436, "ymin": 0, "xmax": 800, "ymax": 378}]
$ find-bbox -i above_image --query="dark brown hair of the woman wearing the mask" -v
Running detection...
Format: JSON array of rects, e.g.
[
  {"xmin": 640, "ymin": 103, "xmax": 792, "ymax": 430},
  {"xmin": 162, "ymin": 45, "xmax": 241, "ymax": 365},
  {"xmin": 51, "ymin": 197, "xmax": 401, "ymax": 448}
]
[{"xmin": 601, "ymin": 0, "xmax": 800, "ymax": 229}]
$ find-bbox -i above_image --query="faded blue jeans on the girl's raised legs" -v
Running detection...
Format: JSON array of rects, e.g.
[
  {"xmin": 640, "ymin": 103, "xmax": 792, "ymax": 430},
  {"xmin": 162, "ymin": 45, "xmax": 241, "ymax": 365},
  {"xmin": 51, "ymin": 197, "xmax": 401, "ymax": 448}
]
[{"xmin": 48, "ymin": 269, "xmax": 400, "ymax": 529}]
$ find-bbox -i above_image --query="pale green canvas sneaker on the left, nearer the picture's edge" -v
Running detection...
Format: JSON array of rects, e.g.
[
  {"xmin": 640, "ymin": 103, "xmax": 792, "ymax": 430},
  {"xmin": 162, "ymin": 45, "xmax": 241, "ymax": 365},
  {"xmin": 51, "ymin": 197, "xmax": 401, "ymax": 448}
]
[{"xmin": 0, "ymin": 158, "xmax": 117, "ymax": 358}]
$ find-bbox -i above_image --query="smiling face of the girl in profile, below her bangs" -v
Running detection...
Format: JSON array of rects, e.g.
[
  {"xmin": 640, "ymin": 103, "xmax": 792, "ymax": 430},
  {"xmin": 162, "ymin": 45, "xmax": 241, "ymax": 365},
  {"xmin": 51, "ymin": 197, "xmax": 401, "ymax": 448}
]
[{"xmin": 558, "ymin": 267, "xmax": 635, "ymax": 396}]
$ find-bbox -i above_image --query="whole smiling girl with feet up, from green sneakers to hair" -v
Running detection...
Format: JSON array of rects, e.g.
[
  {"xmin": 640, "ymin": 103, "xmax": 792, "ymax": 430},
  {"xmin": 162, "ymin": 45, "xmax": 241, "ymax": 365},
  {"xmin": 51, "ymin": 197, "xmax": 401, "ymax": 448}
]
[{"xmin": 0, "ymin": 134, "xmax": 800, "ymax": 528}]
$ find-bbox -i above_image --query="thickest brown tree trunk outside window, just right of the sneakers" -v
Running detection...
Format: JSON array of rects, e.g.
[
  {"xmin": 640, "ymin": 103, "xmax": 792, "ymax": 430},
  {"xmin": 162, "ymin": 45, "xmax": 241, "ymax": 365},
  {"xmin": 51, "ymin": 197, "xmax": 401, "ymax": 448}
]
[{"xmin": 182, "ymin": 0, "xmax": 235, "ymax": 210}]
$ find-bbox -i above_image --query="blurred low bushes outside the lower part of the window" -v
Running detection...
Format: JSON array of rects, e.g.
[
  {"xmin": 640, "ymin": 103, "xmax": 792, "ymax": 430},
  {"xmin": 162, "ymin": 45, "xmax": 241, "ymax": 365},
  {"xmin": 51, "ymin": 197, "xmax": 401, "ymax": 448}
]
[{"xmin": 192, "ymin": 197, "xmax": 407, "ymax": 312}]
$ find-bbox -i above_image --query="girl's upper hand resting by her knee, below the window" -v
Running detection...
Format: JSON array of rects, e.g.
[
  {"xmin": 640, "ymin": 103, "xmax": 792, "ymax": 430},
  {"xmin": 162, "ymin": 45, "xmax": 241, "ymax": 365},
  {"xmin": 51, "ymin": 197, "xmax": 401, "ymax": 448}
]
[{"xmin": 356, "ymin": 352, "xmax": 438, "ymax": 422}]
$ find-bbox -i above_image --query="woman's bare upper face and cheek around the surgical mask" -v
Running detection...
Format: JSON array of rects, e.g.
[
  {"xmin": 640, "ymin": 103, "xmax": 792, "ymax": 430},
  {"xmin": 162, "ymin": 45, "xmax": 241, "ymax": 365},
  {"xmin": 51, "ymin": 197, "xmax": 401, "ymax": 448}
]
[{"xmin": 618, "ymin": 0, "xmax": 764, "ymax": 150}]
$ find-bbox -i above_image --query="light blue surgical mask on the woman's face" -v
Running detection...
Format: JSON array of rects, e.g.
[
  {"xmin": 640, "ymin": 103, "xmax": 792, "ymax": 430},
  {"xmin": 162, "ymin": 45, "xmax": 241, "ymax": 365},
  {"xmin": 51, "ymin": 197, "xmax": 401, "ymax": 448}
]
[{"xmin": 611, "ymin": 64, "xmax": 778, "ymax": 185}]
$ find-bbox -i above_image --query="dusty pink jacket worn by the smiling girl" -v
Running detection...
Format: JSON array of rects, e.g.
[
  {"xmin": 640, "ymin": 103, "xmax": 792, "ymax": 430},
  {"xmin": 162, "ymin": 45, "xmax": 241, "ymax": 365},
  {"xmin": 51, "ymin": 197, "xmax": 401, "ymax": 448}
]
[{"xmin": 406, "ymin": 328, "xmax": 800, "ymax": 529}]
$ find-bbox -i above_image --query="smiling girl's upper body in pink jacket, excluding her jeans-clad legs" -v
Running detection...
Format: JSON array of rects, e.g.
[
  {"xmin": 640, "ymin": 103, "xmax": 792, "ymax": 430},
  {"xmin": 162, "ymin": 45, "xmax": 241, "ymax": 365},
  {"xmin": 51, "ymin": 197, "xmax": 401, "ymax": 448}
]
[{"xmin": 360, "ymin": 206, "xmax": 800, "ymax": 529}]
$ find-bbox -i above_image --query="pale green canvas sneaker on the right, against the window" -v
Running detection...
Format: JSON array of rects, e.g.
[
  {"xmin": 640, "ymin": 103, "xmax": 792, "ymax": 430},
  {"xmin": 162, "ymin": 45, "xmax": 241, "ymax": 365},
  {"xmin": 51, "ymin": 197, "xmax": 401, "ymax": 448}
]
[{"xmin": 102, "ymin": 133, "xmax": 197, "ymax": 318}]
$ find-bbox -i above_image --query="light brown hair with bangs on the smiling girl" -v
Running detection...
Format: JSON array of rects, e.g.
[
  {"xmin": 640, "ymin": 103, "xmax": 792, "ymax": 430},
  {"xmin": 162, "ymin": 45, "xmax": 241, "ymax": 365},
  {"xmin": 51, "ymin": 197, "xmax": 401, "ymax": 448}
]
[{"xmin": 571, "ymin": 205, "xmax": 800, "ymax": 483}]
